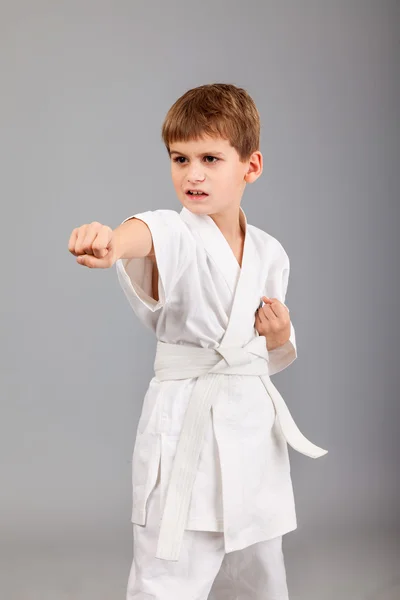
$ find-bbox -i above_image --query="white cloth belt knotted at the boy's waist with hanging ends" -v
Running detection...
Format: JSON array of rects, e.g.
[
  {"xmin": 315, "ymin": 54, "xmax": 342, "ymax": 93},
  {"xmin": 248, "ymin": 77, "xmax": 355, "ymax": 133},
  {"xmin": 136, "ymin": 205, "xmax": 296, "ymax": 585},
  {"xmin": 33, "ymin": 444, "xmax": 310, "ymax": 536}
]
[{"xmin": 154, "ymin": 336, "xmax": 327, "ymax": 561}]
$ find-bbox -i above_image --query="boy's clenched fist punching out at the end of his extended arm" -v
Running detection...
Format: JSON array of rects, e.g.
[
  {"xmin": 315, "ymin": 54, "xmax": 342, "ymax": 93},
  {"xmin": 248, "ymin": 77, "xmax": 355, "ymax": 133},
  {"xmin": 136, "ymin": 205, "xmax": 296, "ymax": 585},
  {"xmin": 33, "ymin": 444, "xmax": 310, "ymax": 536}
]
[{"xmin": 68, "ymin": 221, "xmax": 117, "ymax": 269}]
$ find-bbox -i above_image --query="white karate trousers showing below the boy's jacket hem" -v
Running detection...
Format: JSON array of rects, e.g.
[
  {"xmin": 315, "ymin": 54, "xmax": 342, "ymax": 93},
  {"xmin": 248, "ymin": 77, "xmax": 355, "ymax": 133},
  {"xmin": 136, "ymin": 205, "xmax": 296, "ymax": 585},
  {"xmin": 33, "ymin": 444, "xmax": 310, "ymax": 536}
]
[{"xmin": 126, "ymin": 468, "xmax": 289, "ymax": 600}]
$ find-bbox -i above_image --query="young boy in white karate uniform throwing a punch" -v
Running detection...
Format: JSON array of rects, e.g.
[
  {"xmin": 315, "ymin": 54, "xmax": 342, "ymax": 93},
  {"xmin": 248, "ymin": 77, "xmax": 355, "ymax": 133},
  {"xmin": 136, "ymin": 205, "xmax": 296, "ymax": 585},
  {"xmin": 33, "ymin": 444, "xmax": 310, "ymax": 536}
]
[{"xmin": 69, "ymin": 84, "xmax": 326, "ymax": 600}]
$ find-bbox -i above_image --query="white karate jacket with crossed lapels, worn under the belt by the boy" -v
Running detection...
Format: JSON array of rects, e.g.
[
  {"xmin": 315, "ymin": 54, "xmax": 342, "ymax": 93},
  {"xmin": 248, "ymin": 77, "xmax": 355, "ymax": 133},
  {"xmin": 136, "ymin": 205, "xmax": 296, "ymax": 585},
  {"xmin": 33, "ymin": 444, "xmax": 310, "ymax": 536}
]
[{"xmin": 116, "ymin": 208, "xmax": 326, "ymax": 560}]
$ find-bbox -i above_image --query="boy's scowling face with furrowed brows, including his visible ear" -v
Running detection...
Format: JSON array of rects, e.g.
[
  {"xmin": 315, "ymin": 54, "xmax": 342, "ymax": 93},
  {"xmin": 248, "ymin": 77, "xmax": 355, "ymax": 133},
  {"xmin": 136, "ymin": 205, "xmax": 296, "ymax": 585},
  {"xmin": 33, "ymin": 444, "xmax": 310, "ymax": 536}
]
[{"xmin": 170, "ymin": 136, "xmax": 262, "ymax": 214}]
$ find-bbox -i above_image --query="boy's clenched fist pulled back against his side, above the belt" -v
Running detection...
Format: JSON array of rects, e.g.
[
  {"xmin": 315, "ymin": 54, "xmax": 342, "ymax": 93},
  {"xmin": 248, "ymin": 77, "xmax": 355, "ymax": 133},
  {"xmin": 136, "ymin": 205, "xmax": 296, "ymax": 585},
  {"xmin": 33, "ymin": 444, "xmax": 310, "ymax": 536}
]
[{"xmin": 254, "ymin": 296, "xmax": 290, "ymax": 350}]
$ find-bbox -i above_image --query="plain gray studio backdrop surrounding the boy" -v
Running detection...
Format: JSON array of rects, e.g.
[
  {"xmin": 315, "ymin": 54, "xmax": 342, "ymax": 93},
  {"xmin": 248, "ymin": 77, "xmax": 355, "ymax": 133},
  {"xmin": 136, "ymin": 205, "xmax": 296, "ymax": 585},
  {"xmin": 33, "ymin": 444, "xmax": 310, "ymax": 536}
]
[{"xmin": 0, "ymin": 0, "xmax": 400, "ymax": 600}]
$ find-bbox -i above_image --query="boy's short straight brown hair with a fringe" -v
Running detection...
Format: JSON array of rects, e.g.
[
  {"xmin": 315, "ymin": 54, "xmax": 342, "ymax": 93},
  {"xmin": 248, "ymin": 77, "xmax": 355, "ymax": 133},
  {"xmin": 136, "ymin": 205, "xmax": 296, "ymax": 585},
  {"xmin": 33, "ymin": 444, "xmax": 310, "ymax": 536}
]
[{"xmin": 162, "ymin": 83, "xmax": 260, "ymax": 162}]
